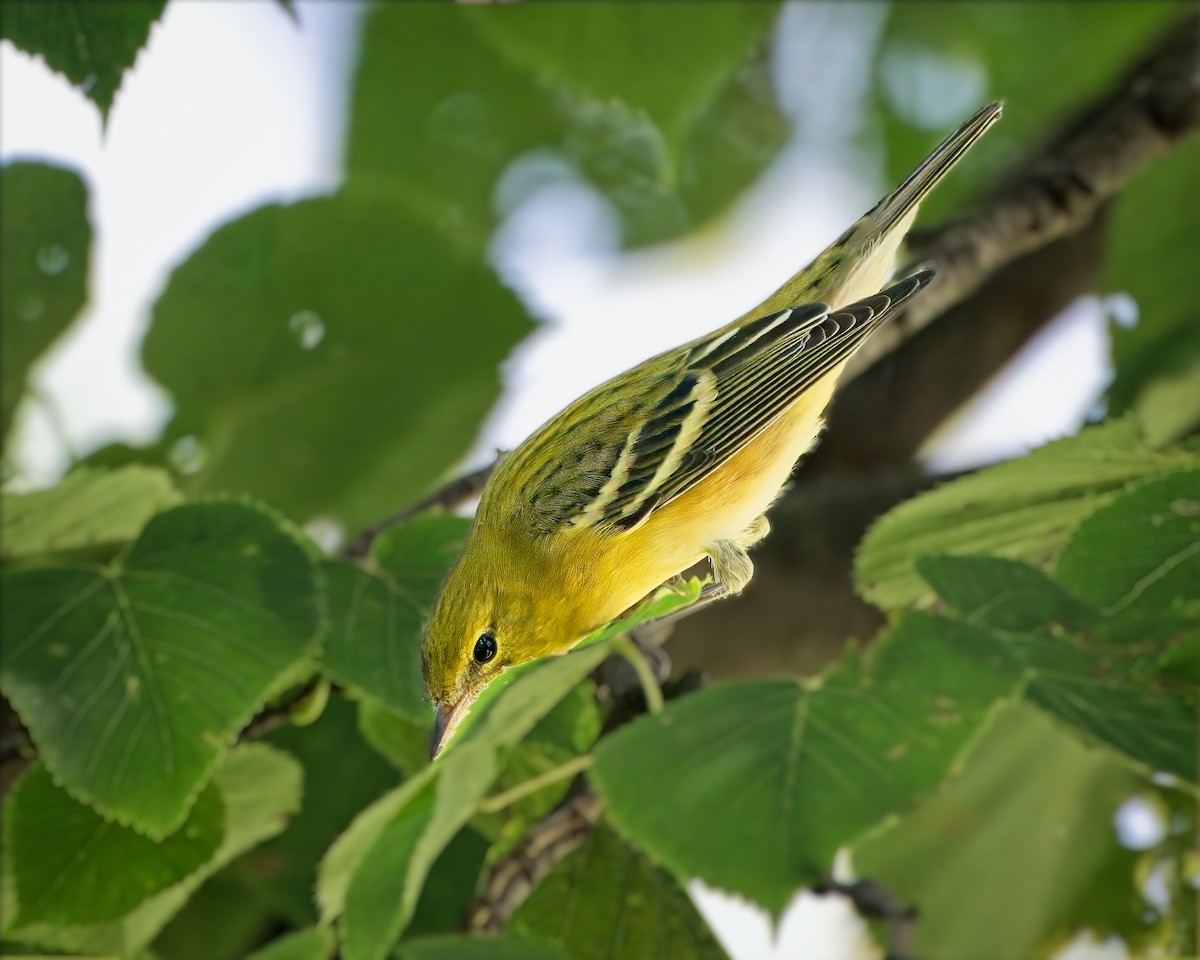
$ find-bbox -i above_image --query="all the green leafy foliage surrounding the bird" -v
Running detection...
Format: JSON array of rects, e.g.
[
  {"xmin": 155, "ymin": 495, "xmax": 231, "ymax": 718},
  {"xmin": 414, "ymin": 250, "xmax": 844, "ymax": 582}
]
[{"xmin": 0, "ymin": 0, "xmax": 1200, "ymax": 960}]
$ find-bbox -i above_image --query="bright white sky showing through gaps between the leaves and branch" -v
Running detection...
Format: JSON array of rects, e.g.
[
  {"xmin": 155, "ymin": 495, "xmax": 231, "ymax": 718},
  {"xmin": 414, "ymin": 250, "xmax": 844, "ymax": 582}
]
[{"xmin": 0, "ymin": 0, "xmax": 1108, "ymax": 960}]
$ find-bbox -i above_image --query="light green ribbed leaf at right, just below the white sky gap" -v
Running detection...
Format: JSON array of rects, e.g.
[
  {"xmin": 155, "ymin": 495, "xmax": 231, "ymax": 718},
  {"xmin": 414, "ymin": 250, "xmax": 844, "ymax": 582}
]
[{"xmin": 854, "ymin": 418, "xmax": 1196, "ymax": 608}]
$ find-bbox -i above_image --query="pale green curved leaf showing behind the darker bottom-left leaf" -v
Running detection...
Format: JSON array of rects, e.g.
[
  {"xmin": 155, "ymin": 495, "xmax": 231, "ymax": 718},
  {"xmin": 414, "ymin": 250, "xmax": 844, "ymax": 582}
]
[{"xmin": 0, "ymin": 744, "xmax": 301, "ymax": 956}]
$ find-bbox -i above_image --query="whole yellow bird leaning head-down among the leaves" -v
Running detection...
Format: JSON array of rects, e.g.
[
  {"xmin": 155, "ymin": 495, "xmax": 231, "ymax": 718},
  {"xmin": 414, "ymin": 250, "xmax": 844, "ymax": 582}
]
[{"xmin": 421, "ymin": 103, "xmax": 1001, "ymax": 755}]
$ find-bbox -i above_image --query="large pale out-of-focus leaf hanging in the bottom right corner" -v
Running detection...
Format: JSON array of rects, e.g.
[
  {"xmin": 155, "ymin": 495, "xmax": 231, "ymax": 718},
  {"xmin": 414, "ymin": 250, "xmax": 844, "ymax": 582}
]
[{"xmin": 854, "ymin": 707, "xmax": 1148, "ymax": 960}]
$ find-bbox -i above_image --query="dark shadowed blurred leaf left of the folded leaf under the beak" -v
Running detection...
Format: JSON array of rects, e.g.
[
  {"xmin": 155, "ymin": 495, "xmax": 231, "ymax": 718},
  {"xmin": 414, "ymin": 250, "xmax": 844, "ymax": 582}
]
[{"xmin": 229, "ymin": 697, "xmax": 398, "ymax": 926}]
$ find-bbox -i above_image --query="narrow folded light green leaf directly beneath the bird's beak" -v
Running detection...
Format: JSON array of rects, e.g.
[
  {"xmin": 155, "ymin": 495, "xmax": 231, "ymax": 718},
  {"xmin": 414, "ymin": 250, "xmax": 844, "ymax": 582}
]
[{"xmin": 317, "ymin": 584, "xmax": 697, "ymax": 960}]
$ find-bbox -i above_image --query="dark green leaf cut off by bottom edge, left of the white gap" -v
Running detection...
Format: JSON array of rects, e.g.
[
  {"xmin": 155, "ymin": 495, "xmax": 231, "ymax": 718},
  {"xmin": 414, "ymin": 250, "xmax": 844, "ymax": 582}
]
[{"xmin": 508, "ymin": 827, "xmax": 725, "ymax": 960}]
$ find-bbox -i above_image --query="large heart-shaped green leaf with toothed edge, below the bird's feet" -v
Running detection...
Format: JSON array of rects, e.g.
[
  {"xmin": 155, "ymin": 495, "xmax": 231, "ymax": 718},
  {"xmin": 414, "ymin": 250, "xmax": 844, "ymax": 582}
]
[{"xmin": 589, "ymin": 614, "xmax": 1015, "ymax": 916}]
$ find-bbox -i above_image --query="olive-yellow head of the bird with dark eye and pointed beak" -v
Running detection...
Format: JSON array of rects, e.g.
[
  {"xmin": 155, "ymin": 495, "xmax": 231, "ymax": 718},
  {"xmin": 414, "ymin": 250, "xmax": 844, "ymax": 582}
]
[{"xmin": 421, "ymin": 532, "xmax": 589, "ymax": 756}]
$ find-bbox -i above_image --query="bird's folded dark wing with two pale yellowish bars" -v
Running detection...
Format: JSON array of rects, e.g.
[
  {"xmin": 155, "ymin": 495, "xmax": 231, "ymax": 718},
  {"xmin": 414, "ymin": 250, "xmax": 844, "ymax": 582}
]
[{"xmin": 514, "ymin": 270, "xmax": 932, "ymax": 530}]
